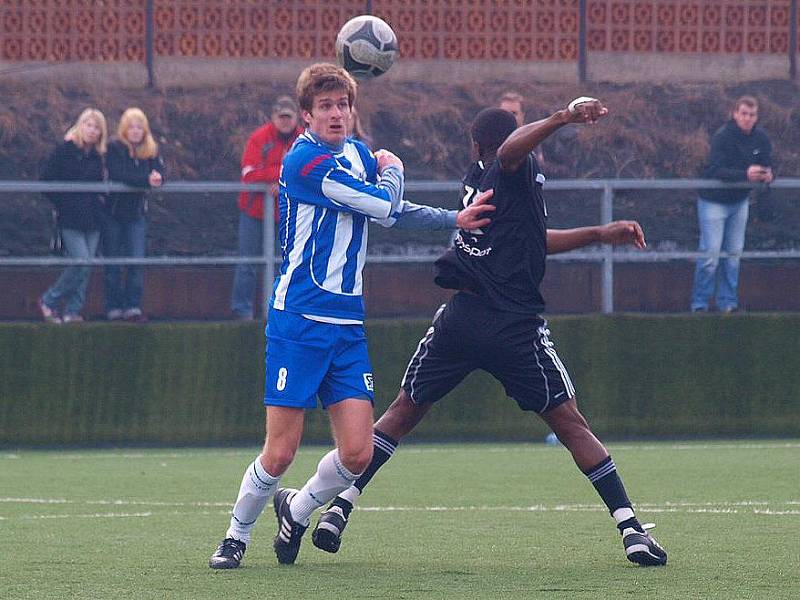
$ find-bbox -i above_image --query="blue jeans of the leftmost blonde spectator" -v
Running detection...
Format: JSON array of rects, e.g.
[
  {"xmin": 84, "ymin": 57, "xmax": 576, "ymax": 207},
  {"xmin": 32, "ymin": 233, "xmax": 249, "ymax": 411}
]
[{"xmin": 42, "ymin": 229, "xmax": 100, "ymax": 315}]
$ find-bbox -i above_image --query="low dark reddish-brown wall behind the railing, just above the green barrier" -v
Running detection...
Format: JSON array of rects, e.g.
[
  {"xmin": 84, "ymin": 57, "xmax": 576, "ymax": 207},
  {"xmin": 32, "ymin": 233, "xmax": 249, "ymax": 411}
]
[{"xmin": 6, "ymin": 261, "xmax": 800, "ymax": 320}]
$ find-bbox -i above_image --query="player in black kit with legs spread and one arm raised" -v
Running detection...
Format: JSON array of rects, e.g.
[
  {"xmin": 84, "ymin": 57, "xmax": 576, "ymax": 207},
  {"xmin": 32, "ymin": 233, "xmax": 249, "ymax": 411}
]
[{"xmin": 312, "ymin": 97, "xmax": 667, "ymax": 566}]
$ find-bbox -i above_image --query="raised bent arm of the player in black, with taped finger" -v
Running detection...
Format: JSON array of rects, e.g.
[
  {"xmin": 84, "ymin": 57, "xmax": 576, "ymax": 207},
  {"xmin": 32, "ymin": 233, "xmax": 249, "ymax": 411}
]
[{"xmin": 497, "ymin": 96, "xmax": 608, "ymax": 171}]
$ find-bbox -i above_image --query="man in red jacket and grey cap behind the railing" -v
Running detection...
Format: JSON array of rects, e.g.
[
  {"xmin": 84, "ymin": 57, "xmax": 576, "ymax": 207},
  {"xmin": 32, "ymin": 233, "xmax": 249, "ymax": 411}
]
[{"xmin": 231, "ymin": 96, "xmax": 303, "ymax": 320}]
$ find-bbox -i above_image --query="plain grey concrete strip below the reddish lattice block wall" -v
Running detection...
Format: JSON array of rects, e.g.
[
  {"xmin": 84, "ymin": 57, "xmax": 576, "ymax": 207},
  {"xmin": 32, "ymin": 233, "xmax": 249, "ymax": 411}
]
[{"xmin": 0, "ymin": 52, "xmax": 789, "ymax": 88}]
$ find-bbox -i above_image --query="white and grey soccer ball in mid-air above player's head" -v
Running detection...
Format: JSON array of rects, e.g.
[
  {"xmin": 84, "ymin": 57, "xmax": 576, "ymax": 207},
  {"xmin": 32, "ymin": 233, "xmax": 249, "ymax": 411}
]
[{"xmin": 336, "ymin": 15, "xmax": 398, "ymax": 79}]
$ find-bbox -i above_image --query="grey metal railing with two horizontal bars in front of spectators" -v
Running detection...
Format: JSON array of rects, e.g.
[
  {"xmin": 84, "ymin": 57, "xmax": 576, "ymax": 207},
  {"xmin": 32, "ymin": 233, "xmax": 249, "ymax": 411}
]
[{"xmin": 0, "ymin": 178, "xmax": 800, "ymax": 313}]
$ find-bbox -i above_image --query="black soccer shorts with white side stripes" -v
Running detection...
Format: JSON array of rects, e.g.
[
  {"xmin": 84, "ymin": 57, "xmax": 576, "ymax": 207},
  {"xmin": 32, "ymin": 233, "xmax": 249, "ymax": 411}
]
[{"xmin": 401, "ymin": 293, "xmax": 575, "ymax": 413}]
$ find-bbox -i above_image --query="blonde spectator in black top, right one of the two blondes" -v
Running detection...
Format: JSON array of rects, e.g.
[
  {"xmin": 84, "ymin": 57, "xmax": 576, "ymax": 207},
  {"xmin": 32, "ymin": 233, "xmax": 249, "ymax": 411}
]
[{"xmin": 102, "ymin": 108, "xmax": 164, "ymax": 322}]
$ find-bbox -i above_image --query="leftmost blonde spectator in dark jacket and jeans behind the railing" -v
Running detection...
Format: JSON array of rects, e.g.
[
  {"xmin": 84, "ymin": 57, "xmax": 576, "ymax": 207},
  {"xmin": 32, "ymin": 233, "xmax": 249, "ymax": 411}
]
[{"xmin": 39, "ymin": 108, "xmax": 108, "ymax": 323}]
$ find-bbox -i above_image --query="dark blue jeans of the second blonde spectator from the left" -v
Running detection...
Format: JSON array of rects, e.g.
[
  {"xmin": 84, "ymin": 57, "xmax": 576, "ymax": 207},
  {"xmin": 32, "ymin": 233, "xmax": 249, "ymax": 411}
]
[{"xmin": 103, "ymin": 214, "xmax": 147, "ymax": 312}]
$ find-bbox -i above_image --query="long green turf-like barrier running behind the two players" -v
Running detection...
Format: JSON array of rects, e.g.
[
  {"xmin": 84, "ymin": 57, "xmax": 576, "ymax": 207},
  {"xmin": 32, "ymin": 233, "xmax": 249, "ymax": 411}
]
[{"xmin": 0, "ymin": 314, "xmax": 800, "ymax": 447}]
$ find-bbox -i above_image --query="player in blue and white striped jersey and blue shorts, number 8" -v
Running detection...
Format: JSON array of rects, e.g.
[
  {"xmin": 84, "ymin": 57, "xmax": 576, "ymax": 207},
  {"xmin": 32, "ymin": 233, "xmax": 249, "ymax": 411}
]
[{"xmin": 209, "ymin": 64, "xmax": 494, "ymax": 569}]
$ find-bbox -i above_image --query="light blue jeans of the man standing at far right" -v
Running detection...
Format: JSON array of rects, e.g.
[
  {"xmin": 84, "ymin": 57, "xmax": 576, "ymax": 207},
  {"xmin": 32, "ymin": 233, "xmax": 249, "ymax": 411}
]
[{"xmin": 692, "ymin": 197, "xmax": 749, "ymax": 311}]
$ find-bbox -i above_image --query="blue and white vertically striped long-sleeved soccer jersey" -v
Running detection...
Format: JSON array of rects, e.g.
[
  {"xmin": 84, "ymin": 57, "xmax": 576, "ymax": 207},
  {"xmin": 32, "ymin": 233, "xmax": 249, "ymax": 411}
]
[{"xmin": 270, "ymin": 131, "xmax": 403, "ymax": 321}]
